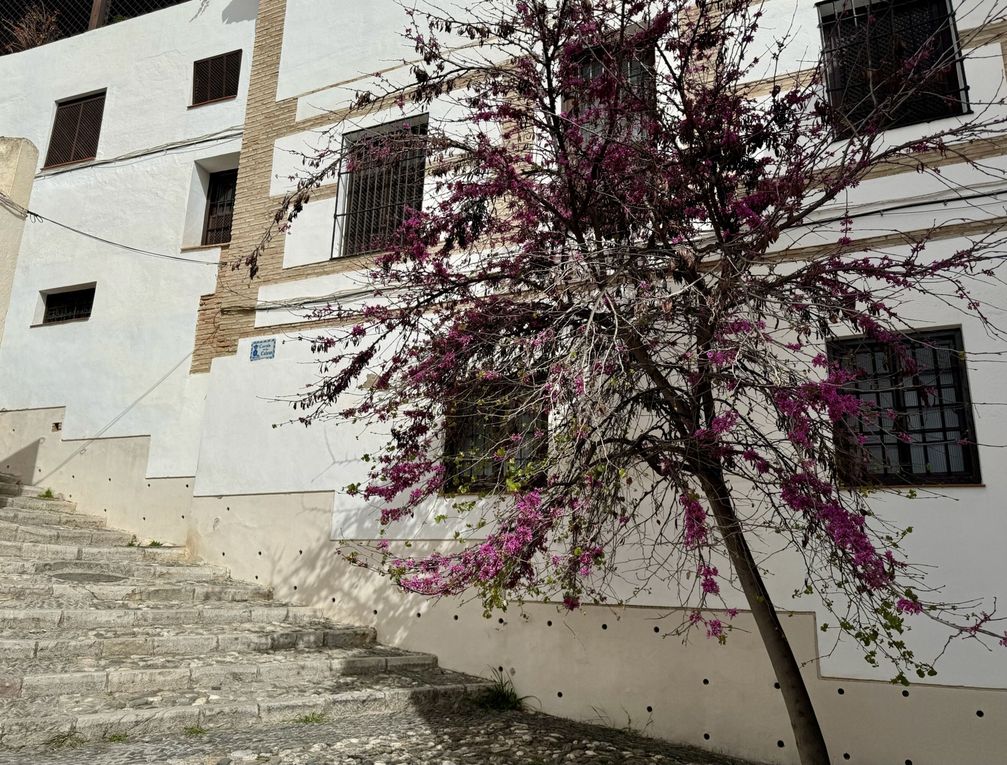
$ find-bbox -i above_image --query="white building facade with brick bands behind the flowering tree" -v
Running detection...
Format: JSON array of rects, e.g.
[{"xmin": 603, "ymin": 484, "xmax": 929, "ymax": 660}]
[{"xmin": 0, "ymin": 0, "xmax": 1007, "ymax": 765}]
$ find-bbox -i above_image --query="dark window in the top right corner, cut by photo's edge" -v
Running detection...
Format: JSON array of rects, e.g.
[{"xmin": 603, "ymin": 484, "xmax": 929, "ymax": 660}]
[{"xmin": 816, "ymin": 0, "xmax": 971, "ymax": 140}]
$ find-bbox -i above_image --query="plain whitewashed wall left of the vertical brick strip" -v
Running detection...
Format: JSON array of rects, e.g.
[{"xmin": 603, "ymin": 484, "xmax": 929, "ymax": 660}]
[{"xmin": 0, "ymin": 0, "xmax": 258, "ymax": 476}]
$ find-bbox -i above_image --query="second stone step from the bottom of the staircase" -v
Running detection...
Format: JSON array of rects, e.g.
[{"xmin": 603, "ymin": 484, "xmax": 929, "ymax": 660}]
[{"xmin": 0, "ymin": 647, "xmax": 437, "ymax": 699}]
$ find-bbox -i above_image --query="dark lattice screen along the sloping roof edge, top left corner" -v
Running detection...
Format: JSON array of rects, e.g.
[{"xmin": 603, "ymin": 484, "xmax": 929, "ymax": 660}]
[{"xmin": 0, "ymin": 0, "xmax": 188, "ymax": 55}]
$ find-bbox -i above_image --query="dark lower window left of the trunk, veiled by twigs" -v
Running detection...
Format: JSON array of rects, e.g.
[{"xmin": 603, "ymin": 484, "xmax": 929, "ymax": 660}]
[{"xmin": 442, "ymin": 381, "xmax": 549, "ymax": 494}]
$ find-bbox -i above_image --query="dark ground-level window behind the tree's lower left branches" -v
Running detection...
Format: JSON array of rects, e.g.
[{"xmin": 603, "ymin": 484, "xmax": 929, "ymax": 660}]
[{"xmin": 444, "ymin": 384, "xmax": 549, "ymax": 493}]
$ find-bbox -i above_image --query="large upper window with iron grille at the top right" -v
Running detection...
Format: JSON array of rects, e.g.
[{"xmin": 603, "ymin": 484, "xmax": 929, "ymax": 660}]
[{"xmin": 818, "ymin": 0, "xmax": 968, "ymax": 138}]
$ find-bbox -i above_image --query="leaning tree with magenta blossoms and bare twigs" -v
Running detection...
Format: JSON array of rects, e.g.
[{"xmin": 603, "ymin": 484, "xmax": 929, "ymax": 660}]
[{"xmin": 265, "ymin": 0, "xmax": 1004, "ymax": 763}]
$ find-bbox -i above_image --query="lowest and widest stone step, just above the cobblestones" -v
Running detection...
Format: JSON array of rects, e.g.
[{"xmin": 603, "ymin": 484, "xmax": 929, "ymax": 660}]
[{"xmin": 0, "ymin": 668, "xmax": 489, "ymax": 748}]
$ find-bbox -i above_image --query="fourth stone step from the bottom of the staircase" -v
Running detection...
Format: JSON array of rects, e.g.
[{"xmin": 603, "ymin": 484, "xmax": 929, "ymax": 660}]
[{"xmin": 0, "ymin": 601, "xmax": 320, "ymax": 638}]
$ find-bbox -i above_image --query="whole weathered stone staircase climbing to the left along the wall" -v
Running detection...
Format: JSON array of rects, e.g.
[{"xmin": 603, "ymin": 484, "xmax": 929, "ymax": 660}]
[{"xmin": 0, "ymin": 474, "xmax": 488, "ymax": 752}]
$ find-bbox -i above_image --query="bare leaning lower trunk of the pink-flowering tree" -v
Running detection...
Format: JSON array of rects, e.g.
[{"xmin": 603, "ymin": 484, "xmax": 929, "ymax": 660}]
[{"xmin": 702, "ymin": 471, "xmax": 830, "ymax": 765}]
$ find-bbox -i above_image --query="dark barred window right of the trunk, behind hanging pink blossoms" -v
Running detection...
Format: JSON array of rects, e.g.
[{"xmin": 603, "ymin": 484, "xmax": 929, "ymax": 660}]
[{"xmin": 829, "ymin": 329, "xmax": 981, "ymax": 485}]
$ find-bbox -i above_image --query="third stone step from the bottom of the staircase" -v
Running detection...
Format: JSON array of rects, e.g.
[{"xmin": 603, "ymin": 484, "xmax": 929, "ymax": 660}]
[{"xmin": 0, "ymin": 622, "xmax": 376, "ymax": 666}]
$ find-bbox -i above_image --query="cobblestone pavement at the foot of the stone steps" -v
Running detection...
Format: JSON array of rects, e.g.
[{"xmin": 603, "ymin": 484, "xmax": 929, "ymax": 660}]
[{"xmin": 0, "ymin": 712, "xmax": 751, "ymax": 765}]
